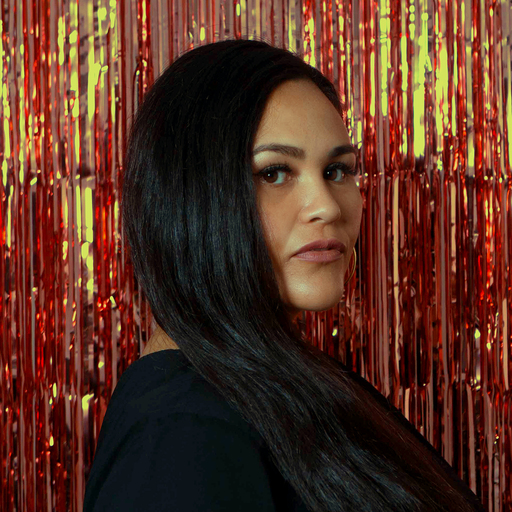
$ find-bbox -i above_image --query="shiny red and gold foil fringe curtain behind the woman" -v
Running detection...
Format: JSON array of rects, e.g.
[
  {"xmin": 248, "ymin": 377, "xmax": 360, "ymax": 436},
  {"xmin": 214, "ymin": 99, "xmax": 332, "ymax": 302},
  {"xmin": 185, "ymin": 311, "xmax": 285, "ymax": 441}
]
[{"xmin": 0, "ymin": 0, "xmax": 512, "ymax": 512}]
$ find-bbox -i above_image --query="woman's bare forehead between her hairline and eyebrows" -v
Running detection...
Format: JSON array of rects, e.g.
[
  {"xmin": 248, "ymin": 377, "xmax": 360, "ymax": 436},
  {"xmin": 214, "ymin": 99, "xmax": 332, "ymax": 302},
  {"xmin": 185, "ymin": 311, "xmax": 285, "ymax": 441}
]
[{"xmin": 256, "ymin": 80, "xmax": 350, "ymax": 144}]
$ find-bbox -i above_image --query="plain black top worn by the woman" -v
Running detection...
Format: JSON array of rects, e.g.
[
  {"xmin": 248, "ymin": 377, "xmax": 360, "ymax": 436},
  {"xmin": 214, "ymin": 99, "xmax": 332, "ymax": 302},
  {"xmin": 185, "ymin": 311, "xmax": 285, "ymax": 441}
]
[{"xmin": 83, "ymin": 349, "xmax": 484, "ymax": 512}]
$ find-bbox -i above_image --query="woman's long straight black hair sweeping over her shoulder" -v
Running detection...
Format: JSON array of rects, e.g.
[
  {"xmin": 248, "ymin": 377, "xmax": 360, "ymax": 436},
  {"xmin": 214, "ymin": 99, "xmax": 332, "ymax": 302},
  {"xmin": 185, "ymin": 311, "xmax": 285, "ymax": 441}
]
[{"xmin": 122, "ymin": 40, "xmax": 483, "ymax": 512}]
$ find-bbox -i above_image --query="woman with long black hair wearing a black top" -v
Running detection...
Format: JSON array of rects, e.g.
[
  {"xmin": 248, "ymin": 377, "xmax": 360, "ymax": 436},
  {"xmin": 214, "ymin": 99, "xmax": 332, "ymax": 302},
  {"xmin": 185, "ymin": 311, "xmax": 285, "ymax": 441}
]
[{"xmin": 84, "ymin": 40, "xmax": 483, "ymax": 512}]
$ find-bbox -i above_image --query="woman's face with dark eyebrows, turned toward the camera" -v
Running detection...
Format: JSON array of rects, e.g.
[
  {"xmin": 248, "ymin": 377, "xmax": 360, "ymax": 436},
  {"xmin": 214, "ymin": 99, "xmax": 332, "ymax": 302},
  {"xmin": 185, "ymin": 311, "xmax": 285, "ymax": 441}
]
[{"xmin": 252, "ymin": 80, "xmax": 363, "ymax": 320}]
